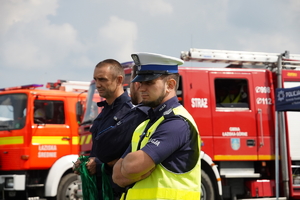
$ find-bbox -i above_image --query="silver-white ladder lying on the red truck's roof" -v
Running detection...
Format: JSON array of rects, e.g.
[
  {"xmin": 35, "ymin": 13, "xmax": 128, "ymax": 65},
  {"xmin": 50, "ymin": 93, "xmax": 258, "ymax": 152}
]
[{"xmin": 180, "ymin": 48, "xmax": 300, "ymax": 67}]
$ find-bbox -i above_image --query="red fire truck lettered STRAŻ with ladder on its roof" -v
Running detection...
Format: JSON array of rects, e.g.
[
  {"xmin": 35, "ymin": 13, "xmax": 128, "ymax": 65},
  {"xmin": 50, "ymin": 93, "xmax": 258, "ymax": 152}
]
[{"xmin": 80, "ymin": 49, "xmax": 300, "ymax": 200}]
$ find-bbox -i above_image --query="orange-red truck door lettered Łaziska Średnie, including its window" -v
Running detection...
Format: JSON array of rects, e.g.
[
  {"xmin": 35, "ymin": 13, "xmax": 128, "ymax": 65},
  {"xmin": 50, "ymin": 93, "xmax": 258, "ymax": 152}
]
[{"xmin": 31, "ymin": 98, "xmax": 72, "ymax": 167}]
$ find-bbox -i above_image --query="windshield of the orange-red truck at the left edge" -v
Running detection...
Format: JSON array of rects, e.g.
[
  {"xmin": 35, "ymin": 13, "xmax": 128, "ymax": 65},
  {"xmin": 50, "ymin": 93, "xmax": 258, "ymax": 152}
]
[{"xmin": 0, "ymin": 93, "xmax": 27, "ymax": 130}]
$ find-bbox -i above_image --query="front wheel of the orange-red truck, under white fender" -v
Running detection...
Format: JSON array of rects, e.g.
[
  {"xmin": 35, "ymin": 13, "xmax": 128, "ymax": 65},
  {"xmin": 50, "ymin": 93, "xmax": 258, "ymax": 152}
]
[{"xmin": 57, "ymin": 174, "xmax": 79, "ymax": 200}]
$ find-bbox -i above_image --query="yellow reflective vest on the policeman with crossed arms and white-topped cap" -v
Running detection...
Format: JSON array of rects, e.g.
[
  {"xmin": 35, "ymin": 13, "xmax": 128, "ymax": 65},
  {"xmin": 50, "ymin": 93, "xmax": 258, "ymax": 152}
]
[{"xmin": 123, "ymin": 106, "xmax": 201, "ymax": 200}]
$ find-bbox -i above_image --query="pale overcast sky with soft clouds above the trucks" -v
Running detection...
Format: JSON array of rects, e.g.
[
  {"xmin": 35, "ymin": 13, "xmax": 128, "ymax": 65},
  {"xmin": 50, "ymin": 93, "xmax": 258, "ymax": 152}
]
[{"xmin": 0, "ymin": 0, "xmax": 300, "ymax": 88}]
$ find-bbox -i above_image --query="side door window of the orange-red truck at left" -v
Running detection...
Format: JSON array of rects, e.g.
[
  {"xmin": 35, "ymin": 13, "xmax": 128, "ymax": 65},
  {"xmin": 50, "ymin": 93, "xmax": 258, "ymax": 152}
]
[{"xmin": 34, "ymin": 100, "xmax": 65, "ymax": 124}]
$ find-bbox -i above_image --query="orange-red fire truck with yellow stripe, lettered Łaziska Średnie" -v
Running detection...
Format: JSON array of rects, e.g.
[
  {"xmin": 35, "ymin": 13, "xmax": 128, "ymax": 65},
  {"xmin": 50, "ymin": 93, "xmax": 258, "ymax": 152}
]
[{"xmin": 0, "ymin": 80, "xmax": 89, "ymax": 200}]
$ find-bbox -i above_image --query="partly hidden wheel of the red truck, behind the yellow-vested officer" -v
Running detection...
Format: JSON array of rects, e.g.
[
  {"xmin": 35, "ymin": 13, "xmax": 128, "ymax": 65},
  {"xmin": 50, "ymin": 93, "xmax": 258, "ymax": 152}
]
[{"xmin": 201, "ymin": 170, "xmax": 215, "ymax": 200}]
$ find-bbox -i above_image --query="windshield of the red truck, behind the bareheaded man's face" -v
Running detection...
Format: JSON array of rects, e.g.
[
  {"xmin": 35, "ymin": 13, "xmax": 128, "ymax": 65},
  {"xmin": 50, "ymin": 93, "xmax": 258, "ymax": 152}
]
[{"xmin": 82, "ymin": 82, "xmax": 104, "ymax": 123}]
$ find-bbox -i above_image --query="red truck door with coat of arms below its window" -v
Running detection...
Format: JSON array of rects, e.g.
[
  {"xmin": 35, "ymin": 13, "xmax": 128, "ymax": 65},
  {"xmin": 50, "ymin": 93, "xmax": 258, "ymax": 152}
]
[{"xmin": 209, "ymin": 71, "xmax": 258, "ymax": 161}]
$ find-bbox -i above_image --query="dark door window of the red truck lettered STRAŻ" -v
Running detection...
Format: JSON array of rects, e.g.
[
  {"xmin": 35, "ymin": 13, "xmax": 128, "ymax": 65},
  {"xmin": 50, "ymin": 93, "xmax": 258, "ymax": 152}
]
[{"xmin": 215, "ymin": 79, "xmax": 249, "ymax": 109}]
